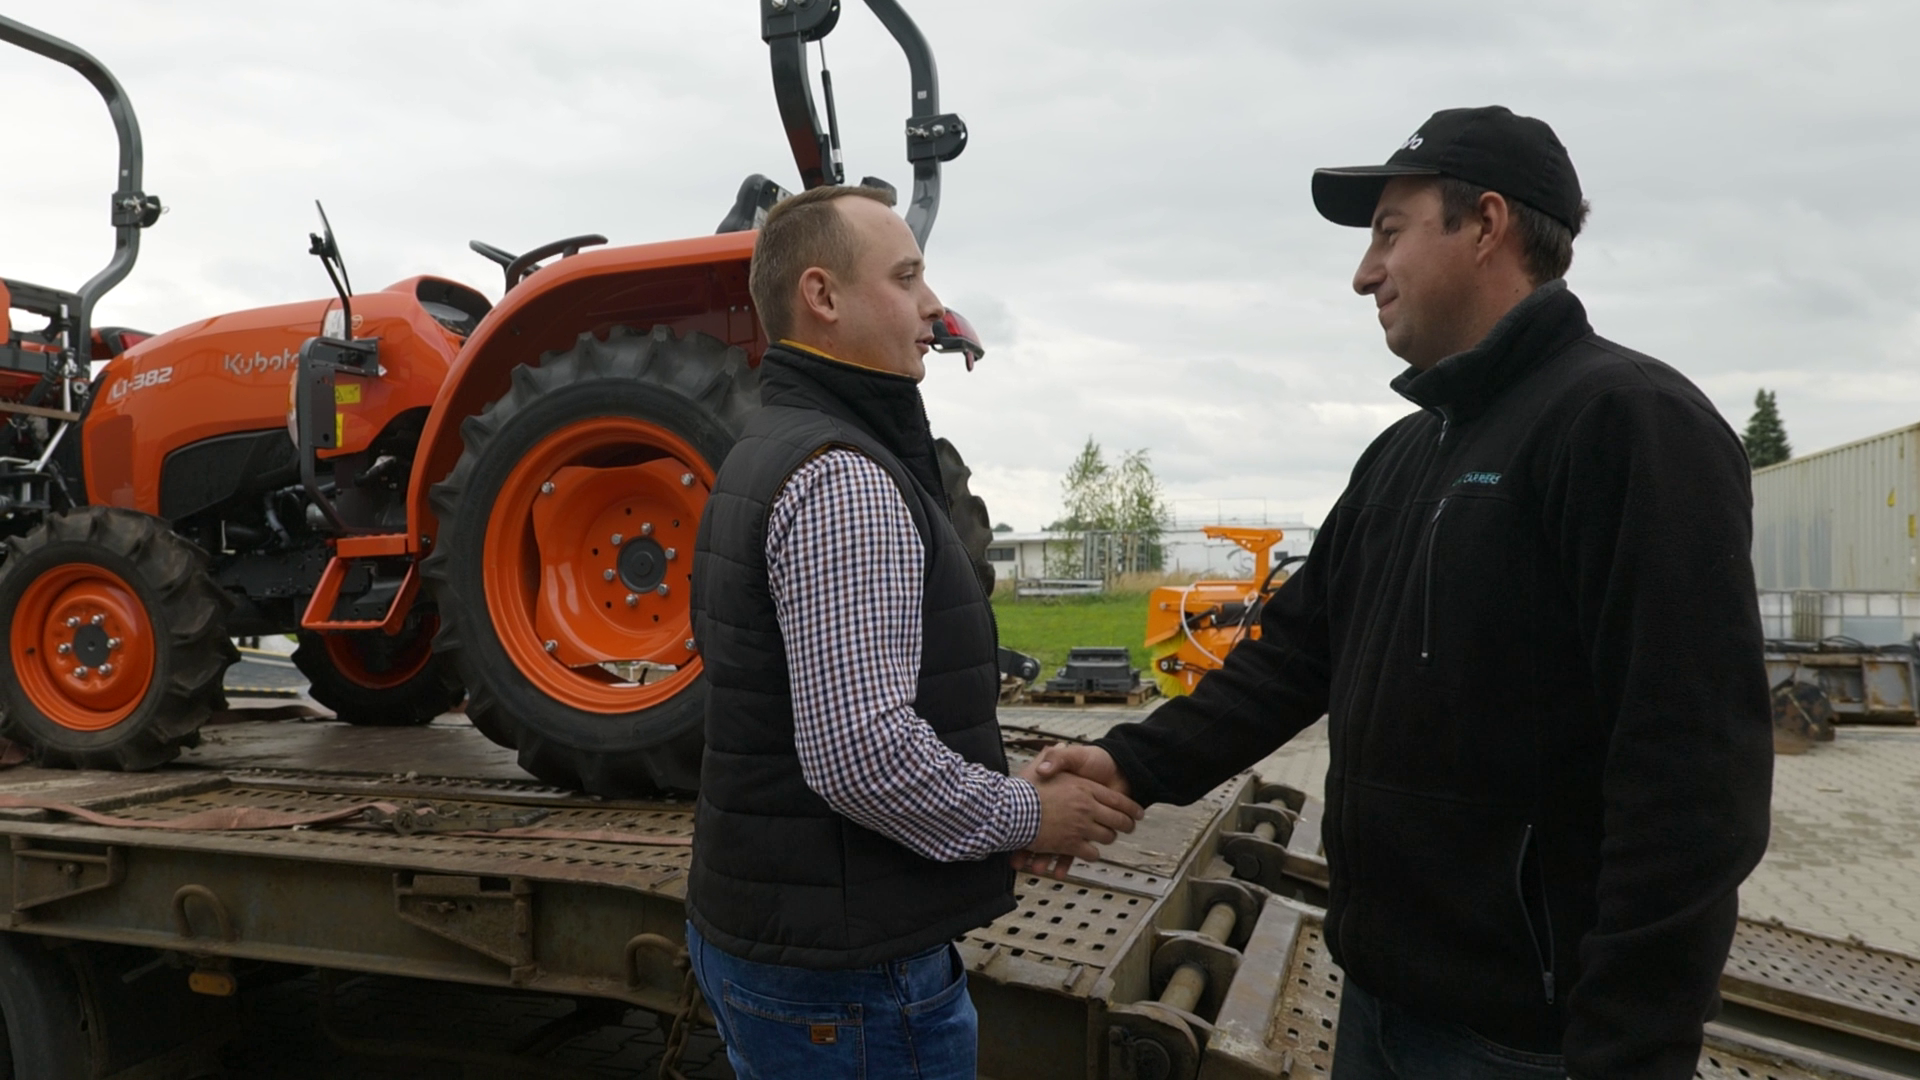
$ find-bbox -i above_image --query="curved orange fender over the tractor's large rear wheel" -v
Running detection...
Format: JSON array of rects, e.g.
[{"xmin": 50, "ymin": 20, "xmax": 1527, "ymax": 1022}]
[{"xmin": 407, "ymin": 233, "xmax": 766, "ymax": 550}]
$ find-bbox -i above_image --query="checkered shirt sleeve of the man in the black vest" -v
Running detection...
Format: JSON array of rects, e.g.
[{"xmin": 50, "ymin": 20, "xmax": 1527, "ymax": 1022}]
[{"xmin": 766, "ymin": 450, "xmax": 1041, "ymax": 863}]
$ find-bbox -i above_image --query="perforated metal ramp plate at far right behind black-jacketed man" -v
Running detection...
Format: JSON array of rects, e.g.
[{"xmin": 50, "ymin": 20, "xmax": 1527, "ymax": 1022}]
[{"xmin": 1720, "ymin": 920, "xmax": 1920, "ymax": 1049}]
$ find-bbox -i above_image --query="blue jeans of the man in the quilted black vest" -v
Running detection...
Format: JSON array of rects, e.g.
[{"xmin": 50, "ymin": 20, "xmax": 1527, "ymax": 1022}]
[{"xmin": 687, "ymin": 922, "xmax": 979, "ymax": 1080}]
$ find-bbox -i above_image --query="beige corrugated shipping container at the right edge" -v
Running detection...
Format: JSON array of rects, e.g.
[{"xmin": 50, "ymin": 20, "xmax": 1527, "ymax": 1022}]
[{"xmin": 1753, "ymin": 425, "xmax": 1920, "ymax": 592}]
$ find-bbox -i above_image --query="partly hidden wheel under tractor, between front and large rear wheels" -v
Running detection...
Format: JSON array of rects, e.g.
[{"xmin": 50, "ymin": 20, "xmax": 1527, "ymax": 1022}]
[{"xmin": 294, "ymin": 607, "xmax": 467, "ymax": 728}]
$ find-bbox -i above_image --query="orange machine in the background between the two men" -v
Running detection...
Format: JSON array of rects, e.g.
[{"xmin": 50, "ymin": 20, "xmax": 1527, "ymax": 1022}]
[{"xmin": 1146, "ymin": 525, "xmax": 1302, "ymax": 698}]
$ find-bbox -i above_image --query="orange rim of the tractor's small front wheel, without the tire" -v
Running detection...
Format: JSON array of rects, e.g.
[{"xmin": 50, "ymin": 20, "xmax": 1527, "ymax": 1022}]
[{"xmin": 10, "ymin": 563, "xmax": 154, "ymax": 732}]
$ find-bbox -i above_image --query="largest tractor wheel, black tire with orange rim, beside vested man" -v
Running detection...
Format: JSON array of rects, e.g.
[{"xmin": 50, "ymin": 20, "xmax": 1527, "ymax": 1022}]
[{"xmin": 422, "ymin": 327, "xmax": 760, "ymax": 796}]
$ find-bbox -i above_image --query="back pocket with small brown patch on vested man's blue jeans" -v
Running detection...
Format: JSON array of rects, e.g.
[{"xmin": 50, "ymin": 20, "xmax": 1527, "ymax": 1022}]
[{"xmin": 720, "ymin": 980, "xmax": 866, "ymax": 1080}]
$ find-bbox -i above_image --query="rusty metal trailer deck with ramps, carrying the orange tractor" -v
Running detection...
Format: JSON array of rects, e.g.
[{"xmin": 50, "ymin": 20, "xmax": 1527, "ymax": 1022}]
[{"xmin": 0, "ymin": 711, "xmax": 1920, "ymax": 1080}]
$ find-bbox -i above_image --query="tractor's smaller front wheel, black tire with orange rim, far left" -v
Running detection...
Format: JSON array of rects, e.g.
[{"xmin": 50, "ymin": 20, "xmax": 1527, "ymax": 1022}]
[{"xmin": 0, "ymin": 505, "xmax": 240, "ymax": 771}]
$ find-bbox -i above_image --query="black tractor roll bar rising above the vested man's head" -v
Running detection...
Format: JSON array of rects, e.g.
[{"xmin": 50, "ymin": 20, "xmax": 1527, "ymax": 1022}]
[{"xmin": 760, "ymin": 0, "xmax": 968, "ymax": 248}]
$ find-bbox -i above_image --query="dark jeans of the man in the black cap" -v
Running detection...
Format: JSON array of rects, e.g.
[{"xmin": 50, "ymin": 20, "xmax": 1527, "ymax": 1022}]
[{"xmin": 1332, "ymin": 980, "xmax": 1567, "ymax": 1080}]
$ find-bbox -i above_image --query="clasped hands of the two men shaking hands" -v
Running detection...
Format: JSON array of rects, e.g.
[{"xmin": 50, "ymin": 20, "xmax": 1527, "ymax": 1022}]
[{"xmin": 1014, "ymin": 746, "xmax": 1146, "ymax": 878}]
